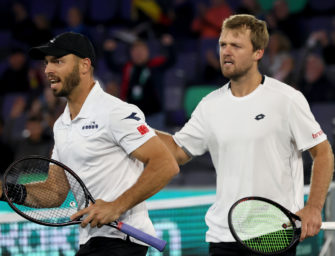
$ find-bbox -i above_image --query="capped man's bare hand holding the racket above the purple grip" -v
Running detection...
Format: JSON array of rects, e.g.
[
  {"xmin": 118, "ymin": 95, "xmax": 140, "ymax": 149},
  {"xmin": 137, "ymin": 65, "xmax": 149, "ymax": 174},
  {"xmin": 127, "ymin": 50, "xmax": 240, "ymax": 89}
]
[{"xmin": 71, "ymin": 199, "xmax": 121, "ymax": 228}]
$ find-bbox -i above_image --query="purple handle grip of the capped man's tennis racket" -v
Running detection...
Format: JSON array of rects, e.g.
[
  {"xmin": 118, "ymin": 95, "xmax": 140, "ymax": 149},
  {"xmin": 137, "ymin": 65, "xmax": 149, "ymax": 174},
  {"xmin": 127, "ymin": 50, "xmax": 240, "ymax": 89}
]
[{"xmin": 117, "ymin": 221, "xmax": 166, "ymax": 252}]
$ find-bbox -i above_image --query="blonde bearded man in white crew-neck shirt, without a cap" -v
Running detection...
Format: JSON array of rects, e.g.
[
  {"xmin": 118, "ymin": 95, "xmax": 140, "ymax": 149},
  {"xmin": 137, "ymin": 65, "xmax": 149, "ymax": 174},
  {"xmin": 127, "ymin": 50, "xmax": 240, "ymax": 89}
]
[{"xmin": 156, "ymin": 14, "xmax": 334, "ymax": 256}]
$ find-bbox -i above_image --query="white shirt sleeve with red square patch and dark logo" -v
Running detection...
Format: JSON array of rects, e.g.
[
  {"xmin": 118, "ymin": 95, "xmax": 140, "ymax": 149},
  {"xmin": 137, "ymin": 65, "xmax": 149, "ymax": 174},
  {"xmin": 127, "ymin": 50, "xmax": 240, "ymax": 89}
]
[{"xmin": 109, "ymin": 104, "xmax": 156, "ymax": 154}]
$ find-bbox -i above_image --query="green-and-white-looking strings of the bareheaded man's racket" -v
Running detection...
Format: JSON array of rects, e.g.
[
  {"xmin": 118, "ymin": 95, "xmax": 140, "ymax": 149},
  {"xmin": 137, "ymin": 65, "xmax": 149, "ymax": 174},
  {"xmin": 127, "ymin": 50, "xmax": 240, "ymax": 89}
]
[{"xmin": 232, "ymin": 200, "xmax": 294, "ymax": 253}]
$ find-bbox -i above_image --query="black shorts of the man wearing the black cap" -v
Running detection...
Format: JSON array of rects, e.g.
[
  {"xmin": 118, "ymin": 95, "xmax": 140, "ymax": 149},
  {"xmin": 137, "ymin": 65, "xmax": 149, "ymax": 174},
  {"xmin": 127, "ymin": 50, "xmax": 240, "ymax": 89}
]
[{"xmin": 76, "ymin": 237, "xmax": 148, "ymax": 256}]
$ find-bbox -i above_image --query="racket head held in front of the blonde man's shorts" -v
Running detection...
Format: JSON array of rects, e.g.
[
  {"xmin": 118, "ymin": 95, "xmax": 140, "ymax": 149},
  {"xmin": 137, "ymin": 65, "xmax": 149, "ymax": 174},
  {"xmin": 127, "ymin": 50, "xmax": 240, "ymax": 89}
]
[{"xmin": 228, "ymin": 197, "xmax": 301, "ymax": 255}]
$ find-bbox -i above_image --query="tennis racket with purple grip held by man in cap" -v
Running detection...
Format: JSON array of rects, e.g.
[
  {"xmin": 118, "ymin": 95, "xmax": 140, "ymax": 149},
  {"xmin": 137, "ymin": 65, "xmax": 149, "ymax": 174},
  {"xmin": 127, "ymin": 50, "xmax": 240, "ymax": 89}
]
[{"xmin": 2, "ymin": 156, "xmax": 166, "ymax": 251}]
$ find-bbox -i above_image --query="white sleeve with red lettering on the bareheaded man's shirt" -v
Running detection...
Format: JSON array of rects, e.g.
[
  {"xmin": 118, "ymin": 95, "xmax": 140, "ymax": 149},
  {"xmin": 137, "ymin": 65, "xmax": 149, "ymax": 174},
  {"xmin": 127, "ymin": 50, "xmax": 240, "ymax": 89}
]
[{"xmin": 289, "ymin": 92, "xmax": 327, "ymax": 151}]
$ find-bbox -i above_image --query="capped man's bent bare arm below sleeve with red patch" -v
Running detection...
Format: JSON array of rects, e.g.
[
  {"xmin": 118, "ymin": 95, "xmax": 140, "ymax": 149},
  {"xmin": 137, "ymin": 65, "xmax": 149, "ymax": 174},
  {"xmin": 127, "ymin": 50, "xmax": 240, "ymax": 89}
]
[{"xmin": 71, "ymin": 136, "xmax": 179, "ymax": 227}]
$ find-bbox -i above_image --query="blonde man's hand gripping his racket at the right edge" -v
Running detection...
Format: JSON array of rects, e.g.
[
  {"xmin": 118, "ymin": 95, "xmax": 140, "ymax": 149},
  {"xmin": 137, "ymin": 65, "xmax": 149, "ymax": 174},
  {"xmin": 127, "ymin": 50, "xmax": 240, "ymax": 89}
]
[{"xmin": 296, "ymin": 205, "xmax": 322, "ymax": 241}]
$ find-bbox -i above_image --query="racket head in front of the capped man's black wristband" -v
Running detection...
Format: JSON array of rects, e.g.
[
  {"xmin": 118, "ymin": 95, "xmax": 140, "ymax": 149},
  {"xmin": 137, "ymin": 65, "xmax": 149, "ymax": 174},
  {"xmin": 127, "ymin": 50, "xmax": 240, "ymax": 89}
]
[{"xmin": 2, "ymin": 155, "xmax": 94, "ymax": 226}]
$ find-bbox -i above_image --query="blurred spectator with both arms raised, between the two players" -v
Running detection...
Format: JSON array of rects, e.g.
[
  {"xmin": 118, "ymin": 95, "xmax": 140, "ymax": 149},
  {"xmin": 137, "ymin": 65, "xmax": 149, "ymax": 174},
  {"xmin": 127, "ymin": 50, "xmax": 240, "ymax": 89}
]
[{"xmin": 104, "ymin": 34, "xmax": 176, "ymax": 127}]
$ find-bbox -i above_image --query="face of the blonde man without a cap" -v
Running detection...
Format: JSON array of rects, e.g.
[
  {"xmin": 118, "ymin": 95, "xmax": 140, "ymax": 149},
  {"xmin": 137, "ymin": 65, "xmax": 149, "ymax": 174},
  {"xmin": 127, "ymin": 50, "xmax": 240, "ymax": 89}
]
[{"xmin": 219, "ymin": 28, "xmax": 263, "ymax": 79}]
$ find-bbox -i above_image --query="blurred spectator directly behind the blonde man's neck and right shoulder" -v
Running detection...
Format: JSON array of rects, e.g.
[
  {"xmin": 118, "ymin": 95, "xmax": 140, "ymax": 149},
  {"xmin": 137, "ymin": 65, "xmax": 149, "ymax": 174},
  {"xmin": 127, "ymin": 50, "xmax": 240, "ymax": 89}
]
[{"xmin": 260, "ymin": 31, "xmax": 295, "ymax": 87}]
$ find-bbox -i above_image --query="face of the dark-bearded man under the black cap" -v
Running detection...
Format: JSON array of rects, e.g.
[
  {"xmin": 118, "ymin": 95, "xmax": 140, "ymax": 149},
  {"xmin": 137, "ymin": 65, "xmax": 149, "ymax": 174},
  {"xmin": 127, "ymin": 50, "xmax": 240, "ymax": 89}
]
[{"xmin": 45, "ymin": 54, "xmax": 81, "ymax": 97}]
